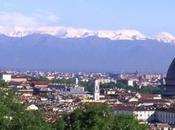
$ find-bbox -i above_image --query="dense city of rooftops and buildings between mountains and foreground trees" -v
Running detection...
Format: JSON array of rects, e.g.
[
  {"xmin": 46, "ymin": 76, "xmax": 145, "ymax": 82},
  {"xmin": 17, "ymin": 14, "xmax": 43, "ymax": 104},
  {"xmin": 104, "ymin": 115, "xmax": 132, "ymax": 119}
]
[{"xmin": 1, "ymin": 65, "xmax": 175, "ymax": 130}]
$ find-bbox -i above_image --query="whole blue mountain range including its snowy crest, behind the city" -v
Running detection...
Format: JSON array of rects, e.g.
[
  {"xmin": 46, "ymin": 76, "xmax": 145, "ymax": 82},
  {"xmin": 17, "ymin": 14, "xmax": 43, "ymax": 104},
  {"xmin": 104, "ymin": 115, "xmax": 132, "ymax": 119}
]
[{"xmin": 0, "ymin": 28, "xmax": 175, "ymax": 72}]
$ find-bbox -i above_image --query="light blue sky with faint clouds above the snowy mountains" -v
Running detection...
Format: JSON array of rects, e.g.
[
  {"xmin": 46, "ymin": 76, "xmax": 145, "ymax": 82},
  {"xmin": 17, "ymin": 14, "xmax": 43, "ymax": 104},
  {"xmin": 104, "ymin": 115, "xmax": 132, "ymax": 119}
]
[{"xmin": 0, "ymin": 0, "xmax": 175, "ymax": 34}]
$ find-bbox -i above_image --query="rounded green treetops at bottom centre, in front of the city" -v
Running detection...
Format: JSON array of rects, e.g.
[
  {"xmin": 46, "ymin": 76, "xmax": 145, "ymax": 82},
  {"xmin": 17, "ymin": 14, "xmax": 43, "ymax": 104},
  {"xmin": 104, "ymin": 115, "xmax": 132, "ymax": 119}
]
[{"xmin": 56, "ymin": 104, "xmax": 146, "ymax": 130}]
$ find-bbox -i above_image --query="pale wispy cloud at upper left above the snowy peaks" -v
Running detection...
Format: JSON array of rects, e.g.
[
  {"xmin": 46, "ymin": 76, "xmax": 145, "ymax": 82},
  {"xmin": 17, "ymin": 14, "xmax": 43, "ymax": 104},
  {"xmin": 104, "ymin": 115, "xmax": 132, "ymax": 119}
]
[{"xmin": 0, "ymin": 12, "xmax": 59, "ymax": 28}]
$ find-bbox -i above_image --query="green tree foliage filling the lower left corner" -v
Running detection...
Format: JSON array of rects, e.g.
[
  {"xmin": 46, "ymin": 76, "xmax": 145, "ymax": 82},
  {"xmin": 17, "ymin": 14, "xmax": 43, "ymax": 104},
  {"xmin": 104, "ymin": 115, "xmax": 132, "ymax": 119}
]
[{"xmin": 0, "ymin": 88, "xmax": 51, "ymax": 130}]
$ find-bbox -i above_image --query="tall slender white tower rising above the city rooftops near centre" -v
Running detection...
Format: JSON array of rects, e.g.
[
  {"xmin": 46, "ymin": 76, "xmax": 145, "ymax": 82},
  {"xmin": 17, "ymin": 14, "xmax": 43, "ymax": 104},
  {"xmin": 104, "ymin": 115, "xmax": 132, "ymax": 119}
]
[{"xmin": 94, "ymin": 80, "xmax": 100, "ymax": 101}]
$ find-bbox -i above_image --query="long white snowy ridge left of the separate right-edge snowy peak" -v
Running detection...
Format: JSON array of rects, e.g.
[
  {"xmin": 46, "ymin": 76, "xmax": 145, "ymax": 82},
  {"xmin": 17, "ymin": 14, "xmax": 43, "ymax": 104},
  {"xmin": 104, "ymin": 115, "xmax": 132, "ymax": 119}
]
[{"xmin": 0, "ymin": 27, "xmax": 146, "ymax": 40}]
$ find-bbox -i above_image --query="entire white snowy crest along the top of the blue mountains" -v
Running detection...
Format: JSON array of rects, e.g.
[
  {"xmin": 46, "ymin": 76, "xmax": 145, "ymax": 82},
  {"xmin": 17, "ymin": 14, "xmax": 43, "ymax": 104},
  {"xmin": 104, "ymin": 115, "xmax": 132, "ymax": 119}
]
[{"xmin": 0, "ymin": 26, "xmax": 175, "ymax": 43}]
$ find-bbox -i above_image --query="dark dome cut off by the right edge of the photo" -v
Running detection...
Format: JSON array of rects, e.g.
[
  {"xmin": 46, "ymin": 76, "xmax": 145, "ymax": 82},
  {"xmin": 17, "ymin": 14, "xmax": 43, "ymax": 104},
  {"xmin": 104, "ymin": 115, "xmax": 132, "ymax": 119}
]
[{"xmin": 162, "ymin": 59, "xmax": 175, "ymax": 97}]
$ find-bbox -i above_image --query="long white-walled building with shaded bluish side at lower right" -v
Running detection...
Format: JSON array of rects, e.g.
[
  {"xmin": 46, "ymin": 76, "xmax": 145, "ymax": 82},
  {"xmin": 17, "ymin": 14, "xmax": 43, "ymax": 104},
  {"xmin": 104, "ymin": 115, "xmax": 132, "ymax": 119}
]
[{"xmin": 113, "ymin": 106, "xmax": 175, "ymax": 125}]
